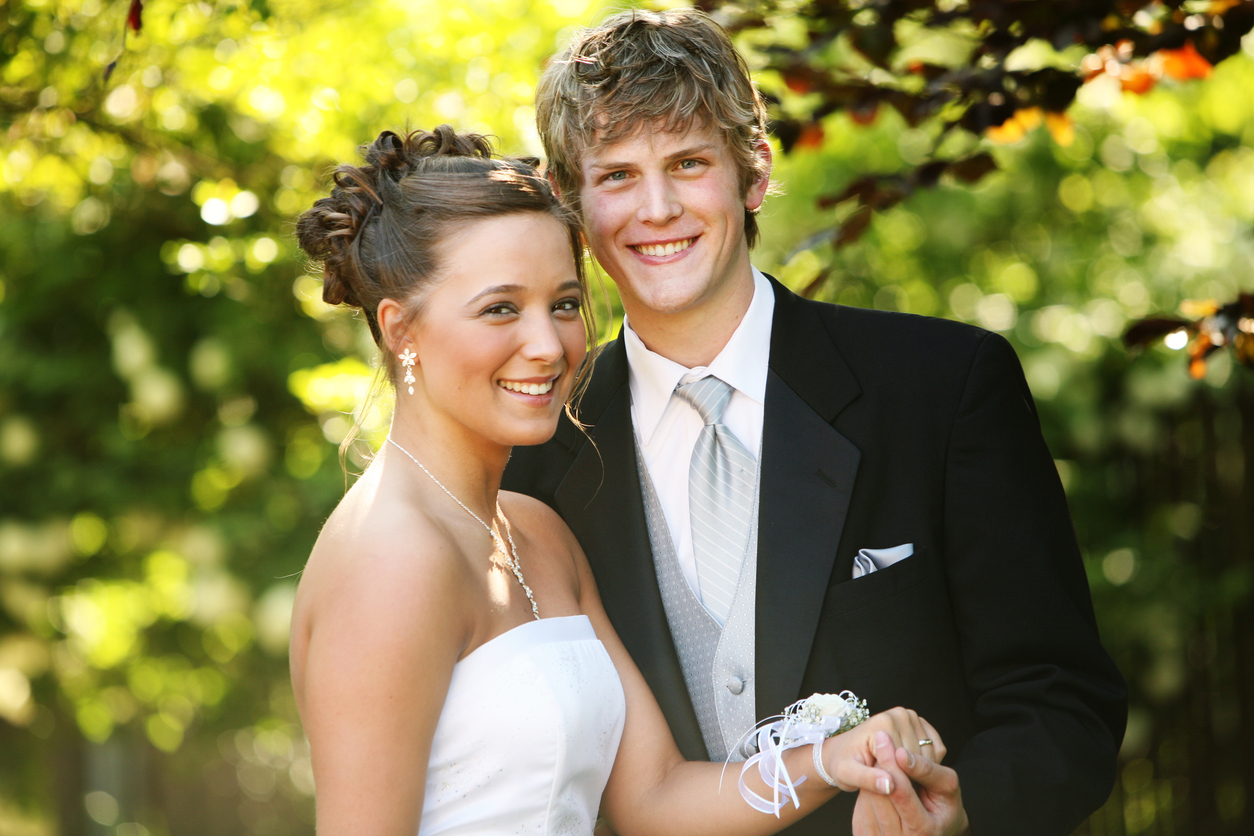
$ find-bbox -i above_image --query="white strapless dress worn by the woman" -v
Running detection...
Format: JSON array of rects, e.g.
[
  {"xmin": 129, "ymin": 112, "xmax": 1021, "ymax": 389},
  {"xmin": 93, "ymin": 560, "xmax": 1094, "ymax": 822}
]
[{"xmin": 418, "ymin": 615, "xmax": 626, "ymax": 836}]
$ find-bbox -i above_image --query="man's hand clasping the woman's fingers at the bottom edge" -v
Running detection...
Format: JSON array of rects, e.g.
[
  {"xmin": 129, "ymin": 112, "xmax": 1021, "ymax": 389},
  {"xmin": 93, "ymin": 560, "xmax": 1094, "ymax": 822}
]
[{"xmin": 853, "ymin": 732, "xmax": 971, "ymax": 836}]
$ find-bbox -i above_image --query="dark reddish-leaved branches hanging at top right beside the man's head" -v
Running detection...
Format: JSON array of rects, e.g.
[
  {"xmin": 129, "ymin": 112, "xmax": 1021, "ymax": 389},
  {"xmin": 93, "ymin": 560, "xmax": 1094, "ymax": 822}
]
[{"xmin": 697, "ymin": 0, "xmax": 1254, "ymax": 255}]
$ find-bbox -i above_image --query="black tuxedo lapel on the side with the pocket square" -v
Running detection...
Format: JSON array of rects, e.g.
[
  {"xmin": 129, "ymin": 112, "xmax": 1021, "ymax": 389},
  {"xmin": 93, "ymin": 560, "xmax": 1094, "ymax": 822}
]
[{"xmin": 755, "ymin": 283, "xmax": 861, "ymax": 717}]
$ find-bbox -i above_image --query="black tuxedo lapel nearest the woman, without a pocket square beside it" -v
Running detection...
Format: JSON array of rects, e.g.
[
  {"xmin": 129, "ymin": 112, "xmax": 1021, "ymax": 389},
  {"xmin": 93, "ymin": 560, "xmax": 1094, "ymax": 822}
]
[{"xmin": 556, "ymin": 338, "xmax": 707, "ymax": 760}]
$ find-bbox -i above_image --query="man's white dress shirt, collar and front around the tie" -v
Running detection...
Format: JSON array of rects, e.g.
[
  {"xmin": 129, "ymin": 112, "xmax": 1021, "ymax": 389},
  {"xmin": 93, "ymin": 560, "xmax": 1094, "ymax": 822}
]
[{"xmin": 623, "ymin": 267, "xmax": 775, "ymax": 600}]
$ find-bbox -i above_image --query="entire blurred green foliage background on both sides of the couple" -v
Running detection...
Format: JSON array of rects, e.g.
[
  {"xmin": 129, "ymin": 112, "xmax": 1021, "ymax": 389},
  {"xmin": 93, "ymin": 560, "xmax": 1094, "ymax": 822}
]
[{"xmin": 0, "ymin": 0, "xmax": 1254, "ymax": 836}]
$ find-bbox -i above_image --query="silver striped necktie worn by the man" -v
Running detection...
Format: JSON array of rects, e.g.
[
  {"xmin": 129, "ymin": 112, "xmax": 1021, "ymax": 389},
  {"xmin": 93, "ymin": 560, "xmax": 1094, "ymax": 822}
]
[{"xmin": 675, "ymin": 377, "xmax": 757, "ymax": 624}]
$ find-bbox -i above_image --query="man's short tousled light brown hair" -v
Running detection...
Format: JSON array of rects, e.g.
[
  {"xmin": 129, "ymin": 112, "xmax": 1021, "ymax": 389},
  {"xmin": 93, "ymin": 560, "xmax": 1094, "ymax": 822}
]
[{"xmin": 535, "ymin": 9, "xmax": 769, "ymax": 247}]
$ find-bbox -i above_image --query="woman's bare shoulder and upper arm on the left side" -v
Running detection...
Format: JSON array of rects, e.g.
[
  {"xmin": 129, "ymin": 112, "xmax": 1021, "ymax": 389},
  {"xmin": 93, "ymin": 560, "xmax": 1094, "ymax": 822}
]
[{"xmin": 291, "ymin": 470, "xmax": 483, "ymax": 832}]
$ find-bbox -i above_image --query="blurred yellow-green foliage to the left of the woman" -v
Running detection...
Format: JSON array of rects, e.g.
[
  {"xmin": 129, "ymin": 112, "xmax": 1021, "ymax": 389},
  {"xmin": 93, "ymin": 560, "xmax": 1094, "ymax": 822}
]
[{"xmin": 0, "ymin": 0, "xmax": 606, "ymax": 836}]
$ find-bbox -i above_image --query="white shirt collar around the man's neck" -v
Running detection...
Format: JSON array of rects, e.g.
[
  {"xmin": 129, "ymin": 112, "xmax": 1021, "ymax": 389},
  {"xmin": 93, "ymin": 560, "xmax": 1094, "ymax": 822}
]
[{"xmin": 623, "ymin": 267, "xmax": 775, "ymax": 444}]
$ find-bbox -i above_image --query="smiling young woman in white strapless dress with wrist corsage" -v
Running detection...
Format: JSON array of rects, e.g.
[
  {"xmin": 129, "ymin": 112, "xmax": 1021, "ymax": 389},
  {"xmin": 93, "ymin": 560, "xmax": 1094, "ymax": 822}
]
[{"xmin": 291, "ymin": 125, "xmax": 943, "ymax": 836}]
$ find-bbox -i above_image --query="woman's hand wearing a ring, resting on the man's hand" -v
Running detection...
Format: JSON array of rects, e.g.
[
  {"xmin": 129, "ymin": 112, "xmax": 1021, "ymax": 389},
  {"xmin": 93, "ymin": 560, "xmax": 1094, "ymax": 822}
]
[{"xmin": 823, "ymin": 707, "xmax": 946, "ymax": 795}]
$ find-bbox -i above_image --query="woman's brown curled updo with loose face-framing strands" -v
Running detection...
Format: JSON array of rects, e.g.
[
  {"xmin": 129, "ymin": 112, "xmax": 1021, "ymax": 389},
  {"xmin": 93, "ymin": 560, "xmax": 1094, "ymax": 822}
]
[{"xmin": 296, "ymin": 125, "xmax": 596, "ymax": 382}]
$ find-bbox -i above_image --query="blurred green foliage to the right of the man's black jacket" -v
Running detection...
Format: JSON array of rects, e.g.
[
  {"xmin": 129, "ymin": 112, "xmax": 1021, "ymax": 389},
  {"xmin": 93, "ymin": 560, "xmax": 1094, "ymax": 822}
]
[{"xmin": 742, "ymin": 9, "xmax": 1254, "ymax": 836}]
